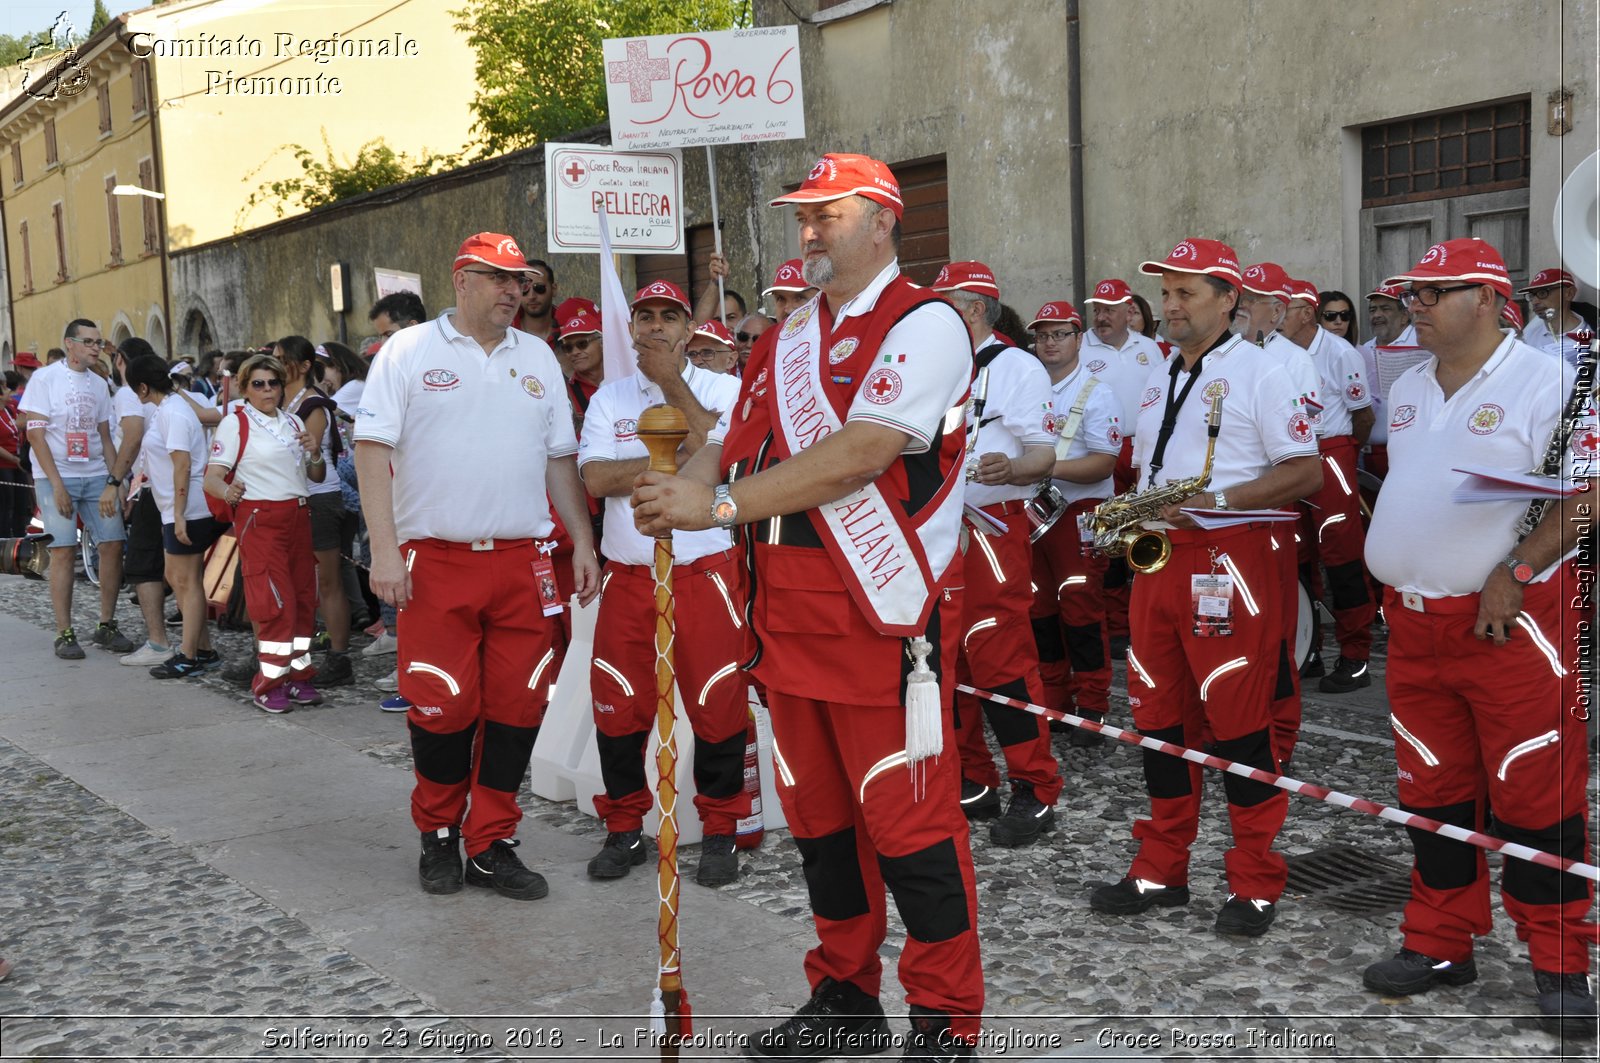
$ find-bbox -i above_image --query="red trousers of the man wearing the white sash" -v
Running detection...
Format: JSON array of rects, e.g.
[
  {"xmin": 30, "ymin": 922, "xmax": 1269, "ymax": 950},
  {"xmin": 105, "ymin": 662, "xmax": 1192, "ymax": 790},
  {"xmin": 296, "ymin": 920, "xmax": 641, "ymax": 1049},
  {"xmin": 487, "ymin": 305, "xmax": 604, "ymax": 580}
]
[{"xmin": 770, "ymin": 690, "xmax": 984, "ymax": 1037}]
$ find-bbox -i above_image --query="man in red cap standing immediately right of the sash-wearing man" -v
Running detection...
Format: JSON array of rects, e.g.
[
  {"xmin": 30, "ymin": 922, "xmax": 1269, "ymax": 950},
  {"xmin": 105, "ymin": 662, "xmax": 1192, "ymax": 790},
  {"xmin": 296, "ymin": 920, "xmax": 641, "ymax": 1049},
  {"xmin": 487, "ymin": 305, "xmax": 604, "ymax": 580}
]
[{"xmin": 933, "ymin": 263, "xmax": 1061, "ymax": 847}]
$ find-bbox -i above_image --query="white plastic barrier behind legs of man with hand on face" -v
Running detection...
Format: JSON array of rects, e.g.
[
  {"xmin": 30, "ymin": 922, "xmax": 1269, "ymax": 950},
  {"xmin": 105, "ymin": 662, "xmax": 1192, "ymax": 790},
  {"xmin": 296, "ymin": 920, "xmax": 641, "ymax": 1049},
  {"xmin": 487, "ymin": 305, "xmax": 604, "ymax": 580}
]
[{"xmin": 528, "ymin": 602, "xmax": 786, "ymax": 844}]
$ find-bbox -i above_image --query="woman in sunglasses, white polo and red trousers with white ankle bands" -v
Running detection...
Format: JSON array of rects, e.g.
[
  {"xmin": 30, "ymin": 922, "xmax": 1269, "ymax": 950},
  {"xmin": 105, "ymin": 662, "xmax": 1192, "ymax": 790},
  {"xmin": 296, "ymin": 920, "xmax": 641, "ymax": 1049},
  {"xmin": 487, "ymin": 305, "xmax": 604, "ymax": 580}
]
[{"xmin": 205, "ymin": 354, "xmax": 328, "ymax": 712}]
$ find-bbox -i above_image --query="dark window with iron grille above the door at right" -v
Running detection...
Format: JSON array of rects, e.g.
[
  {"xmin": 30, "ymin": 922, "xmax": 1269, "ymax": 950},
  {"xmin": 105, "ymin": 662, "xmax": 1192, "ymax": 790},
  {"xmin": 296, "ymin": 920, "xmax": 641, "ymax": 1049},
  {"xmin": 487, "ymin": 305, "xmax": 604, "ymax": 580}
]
[{"xmin": 1362, "ymin": 99, "xmax": 1533, "ymax": 207}]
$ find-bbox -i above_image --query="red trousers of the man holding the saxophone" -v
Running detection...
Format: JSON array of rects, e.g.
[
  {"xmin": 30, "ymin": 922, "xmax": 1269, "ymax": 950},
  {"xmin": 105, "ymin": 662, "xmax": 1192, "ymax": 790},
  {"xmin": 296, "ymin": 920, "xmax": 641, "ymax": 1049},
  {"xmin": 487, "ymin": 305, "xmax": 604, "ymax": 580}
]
[{"xmin": 1128, "ymin": 525, "xmax": 1288, "ymax": 901}]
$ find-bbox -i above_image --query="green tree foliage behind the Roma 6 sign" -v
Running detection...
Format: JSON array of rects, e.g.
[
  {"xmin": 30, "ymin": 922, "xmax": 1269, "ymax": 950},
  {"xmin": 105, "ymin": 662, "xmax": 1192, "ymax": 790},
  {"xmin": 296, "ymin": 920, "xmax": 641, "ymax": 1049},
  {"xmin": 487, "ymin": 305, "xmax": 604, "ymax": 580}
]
[{"xmin": 451, "ymin": 0, "xmax": 750, "ymax": 155}]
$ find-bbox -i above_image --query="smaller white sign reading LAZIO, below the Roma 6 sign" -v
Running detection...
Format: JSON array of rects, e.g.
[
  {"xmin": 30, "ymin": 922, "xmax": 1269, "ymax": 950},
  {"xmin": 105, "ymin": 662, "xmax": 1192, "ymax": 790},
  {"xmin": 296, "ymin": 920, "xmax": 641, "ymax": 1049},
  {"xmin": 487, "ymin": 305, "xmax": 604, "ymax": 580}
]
[{"xmin": 544, "ymin": 144, "xmax": 683, "ymax": 255}]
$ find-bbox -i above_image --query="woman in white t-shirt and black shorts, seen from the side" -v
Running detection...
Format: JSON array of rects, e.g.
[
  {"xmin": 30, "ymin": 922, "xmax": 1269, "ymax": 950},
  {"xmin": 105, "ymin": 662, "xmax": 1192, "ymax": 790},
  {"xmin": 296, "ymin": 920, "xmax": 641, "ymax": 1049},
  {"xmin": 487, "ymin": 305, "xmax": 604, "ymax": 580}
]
[{"xmin": 126, "ymin": 355, "xmax": 226, "ymax": 679}]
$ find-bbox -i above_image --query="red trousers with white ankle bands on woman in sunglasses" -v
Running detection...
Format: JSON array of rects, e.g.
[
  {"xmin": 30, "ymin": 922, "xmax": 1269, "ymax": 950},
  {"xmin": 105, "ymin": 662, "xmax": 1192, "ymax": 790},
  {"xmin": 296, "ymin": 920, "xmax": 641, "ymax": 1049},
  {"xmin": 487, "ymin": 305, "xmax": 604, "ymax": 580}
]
[{"xmin": 234, "ymin": 499, "xmax": 317, "ymax": 695}]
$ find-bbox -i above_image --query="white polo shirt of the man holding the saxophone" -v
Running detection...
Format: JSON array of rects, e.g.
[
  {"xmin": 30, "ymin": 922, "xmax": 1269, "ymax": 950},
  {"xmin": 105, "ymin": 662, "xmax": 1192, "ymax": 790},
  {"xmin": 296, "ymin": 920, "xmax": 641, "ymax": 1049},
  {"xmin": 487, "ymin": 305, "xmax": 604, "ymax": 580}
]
[{"xmin": 1133, "ymin": 336, "xmax": 1317, "ymax": 490}]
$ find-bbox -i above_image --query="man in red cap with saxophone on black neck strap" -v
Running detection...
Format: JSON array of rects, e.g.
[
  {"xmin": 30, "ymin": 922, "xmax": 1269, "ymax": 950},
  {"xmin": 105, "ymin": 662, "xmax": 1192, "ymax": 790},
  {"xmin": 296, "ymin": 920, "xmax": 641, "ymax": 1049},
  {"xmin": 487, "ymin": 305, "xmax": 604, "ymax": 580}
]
[{"xmin": 1090, "ymin": 239, "xmax": 1322, "ymax": 937}]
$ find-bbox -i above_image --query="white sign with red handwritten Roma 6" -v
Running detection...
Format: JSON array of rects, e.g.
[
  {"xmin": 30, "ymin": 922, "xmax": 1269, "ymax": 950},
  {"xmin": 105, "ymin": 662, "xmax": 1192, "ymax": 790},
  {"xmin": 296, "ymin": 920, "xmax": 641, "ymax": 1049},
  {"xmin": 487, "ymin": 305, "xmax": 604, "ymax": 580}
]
[{"xmin": 603, "ymin": 26, "xmax": 805, "ymax": 150}]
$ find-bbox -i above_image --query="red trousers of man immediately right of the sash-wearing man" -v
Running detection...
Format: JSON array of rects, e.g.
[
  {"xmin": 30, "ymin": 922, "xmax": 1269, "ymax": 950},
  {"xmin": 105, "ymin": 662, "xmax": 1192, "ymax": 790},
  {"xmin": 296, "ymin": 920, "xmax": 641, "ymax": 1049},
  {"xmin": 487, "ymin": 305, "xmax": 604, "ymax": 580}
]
[{"xmin": 957, "ymin": 518, "xmax": 1061, "ymax": 805}]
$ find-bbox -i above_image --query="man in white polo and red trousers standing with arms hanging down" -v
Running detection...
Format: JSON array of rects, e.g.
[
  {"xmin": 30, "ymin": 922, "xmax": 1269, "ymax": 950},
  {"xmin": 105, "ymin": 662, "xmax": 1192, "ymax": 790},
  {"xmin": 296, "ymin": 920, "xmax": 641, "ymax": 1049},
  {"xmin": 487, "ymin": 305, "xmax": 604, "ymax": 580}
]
[{"xmin": 355, "ymin": 232, "xmax": 600, "ymax": 900}]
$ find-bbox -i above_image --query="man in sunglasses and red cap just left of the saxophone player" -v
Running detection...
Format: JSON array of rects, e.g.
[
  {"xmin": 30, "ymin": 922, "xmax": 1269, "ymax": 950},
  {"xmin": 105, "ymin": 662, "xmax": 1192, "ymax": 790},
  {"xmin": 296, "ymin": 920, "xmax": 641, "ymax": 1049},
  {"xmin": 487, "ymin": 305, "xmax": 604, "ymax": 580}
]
[{"xmin": 1029, "ymin": 299, "xmax": 1122, "ymax": 748}]
